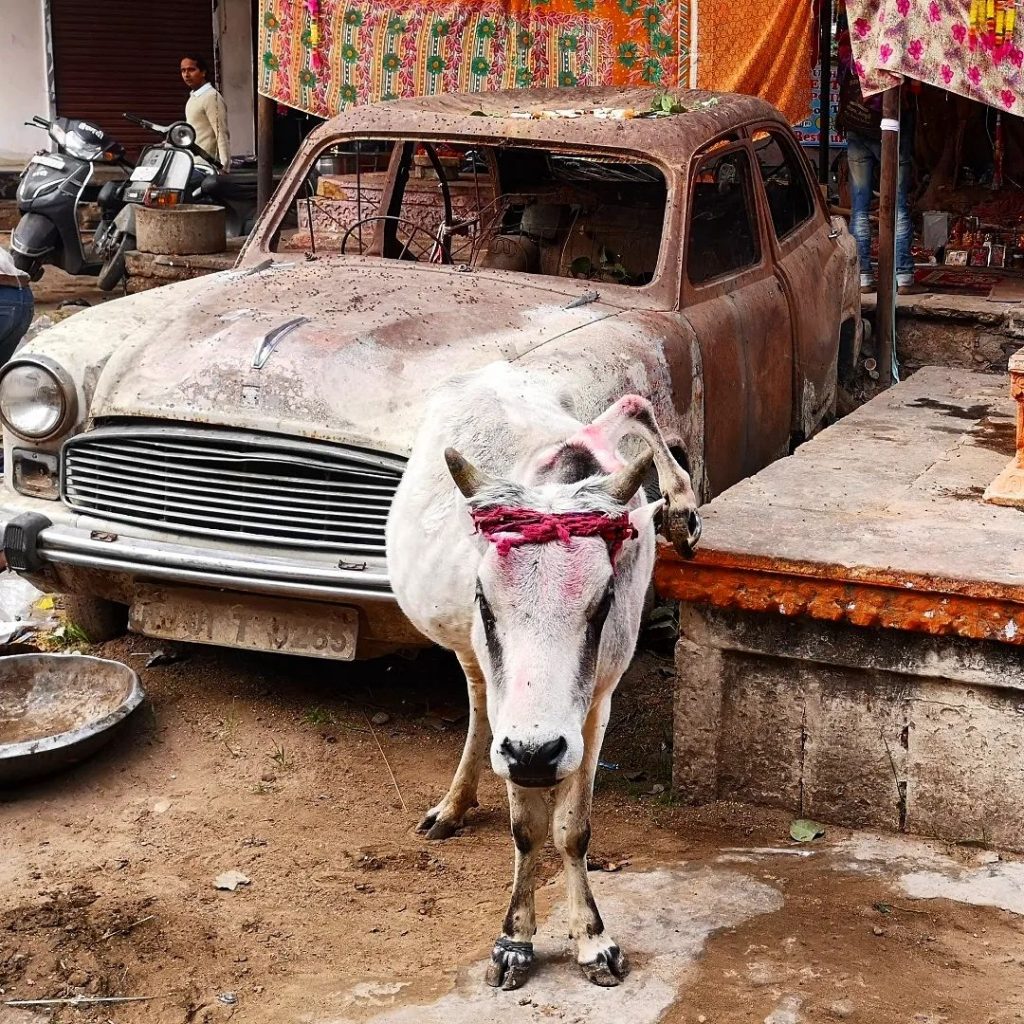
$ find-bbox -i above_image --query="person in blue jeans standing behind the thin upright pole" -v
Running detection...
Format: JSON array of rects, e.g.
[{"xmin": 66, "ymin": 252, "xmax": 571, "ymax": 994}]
[{"xmin": 836, "ymin": 17, "xmax": 925, "ymax": 295}]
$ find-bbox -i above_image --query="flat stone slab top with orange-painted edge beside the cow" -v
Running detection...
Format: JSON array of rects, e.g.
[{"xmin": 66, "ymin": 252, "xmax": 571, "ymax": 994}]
[{"xmin": 655, "ymin": 367, "xmax": 1024, "ymax": 644}]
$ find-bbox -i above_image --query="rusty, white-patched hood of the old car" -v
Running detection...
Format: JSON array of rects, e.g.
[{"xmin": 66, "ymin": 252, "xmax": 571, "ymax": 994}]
[{"xmin": 54, "ymin": 259, "xmax": 620, "ymax": 453}]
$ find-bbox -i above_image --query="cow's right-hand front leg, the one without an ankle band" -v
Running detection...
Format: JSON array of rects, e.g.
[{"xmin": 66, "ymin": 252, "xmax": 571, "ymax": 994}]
[{"xmin": 554, "ymin": 693, "xmax": 630, "ymax": 988}]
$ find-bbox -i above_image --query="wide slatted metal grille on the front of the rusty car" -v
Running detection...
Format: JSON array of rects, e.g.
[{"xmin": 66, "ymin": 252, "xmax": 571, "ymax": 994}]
[{"xmin": 60, "ymin": 426, "xmax": 404, "ymax": 556}]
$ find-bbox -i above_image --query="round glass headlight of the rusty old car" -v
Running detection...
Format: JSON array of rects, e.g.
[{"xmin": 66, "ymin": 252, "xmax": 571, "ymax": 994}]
[{"xmin": 0, "ymin": 355, "xmax": 77, "ymax": 441}]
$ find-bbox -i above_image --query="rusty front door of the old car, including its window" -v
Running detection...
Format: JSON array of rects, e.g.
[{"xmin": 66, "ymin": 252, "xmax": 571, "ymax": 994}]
[{"xmin": 682, "ymin": 141, "xmax": 794, "ymax": 498}]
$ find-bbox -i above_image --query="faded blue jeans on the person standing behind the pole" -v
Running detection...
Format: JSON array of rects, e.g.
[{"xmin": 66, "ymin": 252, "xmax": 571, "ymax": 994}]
[{"xmin": 846, "ymin": 125, "xmax": 913, "ymax": 285}]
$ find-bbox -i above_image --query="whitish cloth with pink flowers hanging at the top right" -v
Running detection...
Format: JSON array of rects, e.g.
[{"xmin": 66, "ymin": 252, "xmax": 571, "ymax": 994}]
[{"xmin": 847, "ymin": 0, "xmax": 1024, "ymax": 114}]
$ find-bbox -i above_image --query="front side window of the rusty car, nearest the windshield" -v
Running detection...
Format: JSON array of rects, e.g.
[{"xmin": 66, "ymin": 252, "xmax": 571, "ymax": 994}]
[{"xmin": 686, "ymin": 150, "xmax": 761, "ymax": 285}]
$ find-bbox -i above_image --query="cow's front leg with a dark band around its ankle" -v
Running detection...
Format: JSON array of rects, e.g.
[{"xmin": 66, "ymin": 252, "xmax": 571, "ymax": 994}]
[{"xmin": 486, "ymin": 782, "xmax": 551, "ymax": 989}]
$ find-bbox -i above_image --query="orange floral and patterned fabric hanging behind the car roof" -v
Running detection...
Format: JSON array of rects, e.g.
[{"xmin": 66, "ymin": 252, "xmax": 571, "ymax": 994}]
[{"xmin": 259, "ymin": 0, "xmax": 812, "ymax": 121}]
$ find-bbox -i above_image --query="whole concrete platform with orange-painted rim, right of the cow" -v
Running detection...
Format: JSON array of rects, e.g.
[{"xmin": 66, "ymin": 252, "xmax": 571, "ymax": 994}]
[{"xmin": 656, "ymin": 367, "xmax": 1024, "ymax": 850}]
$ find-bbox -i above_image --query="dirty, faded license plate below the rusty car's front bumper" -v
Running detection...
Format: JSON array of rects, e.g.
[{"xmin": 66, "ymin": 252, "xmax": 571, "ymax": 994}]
[{"xmin": 130, "ymin": 585, "xmax": 358, "ymax": 662}]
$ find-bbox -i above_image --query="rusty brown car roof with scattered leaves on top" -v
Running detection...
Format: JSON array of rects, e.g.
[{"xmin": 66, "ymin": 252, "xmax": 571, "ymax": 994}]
[{"xmin": 317, "ymin": 87, "xmax": 787, "ymax": 165}]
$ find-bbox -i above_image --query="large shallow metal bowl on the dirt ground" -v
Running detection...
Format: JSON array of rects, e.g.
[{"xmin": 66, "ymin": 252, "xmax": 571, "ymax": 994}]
[{"xmin": 0, "ymin": 654, "xmax": 144, "ymax": 785}]
